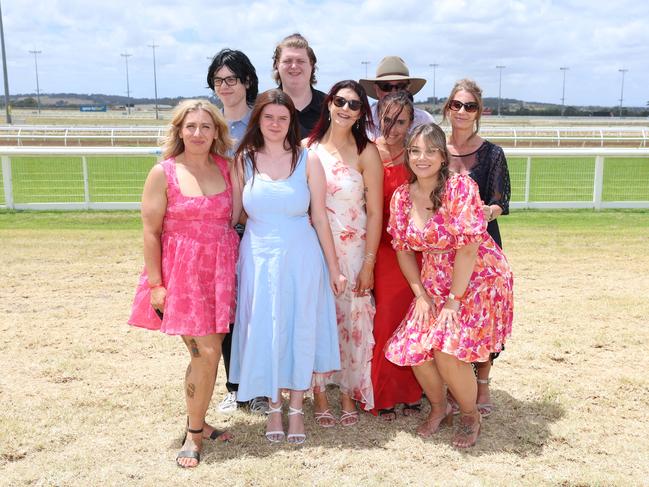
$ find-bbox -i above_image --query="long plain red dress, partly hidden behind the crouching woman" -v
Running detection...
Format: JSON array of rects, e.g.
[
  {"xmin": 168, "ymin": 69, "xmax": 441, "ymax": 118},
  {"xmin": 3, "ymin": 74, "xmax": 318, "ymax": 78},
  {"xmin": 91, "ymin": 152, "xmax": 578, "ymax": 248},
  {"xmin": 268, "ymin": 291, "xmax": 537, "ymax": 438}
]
[{"xmin": 371, "ymin": 161, "xmax": 421, "ymax": 415}]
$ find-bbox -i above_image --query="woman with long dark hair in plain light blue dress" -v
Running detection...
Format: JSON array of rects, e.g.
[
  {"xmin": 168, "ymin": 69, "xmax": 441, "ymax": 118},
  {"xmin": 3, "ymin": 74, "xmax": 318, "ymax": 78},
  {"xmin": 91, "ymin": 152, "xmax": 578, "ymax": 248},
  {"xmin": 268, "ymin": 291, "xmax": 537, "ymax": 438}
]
[{"xmin": 230, "ymin": 90, "xmax": 346, "ymax": 443}]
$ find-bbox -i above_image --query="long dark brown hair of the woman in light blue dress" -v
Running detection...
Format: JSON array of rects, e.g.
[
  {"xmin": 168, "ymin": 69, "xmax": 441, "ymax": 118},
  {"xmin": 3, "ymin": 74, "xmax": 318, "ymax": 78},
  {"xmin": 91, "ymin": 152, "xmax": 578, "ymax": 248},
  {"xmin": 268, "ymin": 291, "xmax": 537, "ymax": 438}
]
[{"xmin": 234, "ymin": 89, "xmax": 301, "ymax": 177}]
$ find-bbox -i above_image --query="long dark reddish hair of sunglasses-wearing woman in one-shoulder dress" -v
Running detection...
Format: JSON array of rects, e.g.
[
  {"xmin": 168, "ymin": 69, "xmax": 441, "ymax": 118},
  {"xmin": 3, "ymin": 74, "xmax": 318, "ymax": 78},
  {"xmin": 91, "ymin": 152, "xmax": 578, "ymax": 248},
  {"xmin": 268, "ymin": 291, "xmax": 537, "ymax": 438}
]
[{"xmin": 307, "ymin": 79, "xmax": 374, "ymax": 154}]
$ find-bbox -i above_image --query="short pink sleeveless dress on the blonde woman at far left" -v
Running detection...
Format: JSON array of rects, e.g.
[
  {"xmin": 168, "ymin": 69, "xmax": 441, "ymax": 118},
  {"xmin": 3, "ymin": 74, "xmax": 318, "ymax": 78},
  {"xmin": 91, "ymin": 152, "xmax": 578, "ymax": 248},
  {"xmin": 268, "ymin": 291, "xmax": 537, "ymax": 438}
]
[{"xmin": 128, "ymin": 156, "xmax": 239, "ymax": 336}]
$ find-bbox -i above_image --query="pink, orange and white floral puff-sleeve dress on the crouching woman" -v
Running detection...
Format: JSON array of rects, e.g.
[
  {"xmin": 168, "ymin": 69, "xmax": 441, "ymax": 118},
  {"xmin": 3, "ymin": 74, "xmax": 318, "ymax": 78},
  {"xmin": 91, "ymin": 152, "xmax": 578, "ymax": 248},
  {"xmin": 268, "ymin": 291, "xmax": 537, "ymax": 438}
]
[{"xmin": 385, "ymin": 175, "xmax": 514, "ymax": 365}]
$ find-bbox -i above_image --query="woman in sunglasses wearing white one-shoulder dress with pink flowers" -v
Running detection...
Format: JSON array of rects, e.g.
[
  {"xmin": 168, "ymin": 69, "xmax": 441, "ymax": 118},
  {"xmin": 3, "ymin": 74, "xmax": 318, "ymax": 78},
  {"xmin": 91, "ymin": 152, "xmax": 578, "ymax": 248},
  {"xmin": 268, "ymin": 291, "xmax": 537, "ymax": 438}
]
[{"xmin": 307, "ymin": 80, "xmax": 383, "ymax": 428}]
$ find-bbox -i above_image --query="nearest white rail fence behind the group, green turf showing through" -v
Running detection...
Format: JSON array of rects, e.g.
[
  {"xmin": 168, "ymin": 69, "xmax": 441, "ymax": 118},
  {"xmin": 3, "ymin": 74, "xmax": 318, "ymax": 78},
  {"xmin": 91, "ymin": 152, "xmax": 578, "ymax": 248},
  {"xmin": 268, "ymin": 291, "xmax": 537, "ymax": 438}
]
[{"xmin": 0, "ymin": 147, "xmax": 649, "ymax": 210}]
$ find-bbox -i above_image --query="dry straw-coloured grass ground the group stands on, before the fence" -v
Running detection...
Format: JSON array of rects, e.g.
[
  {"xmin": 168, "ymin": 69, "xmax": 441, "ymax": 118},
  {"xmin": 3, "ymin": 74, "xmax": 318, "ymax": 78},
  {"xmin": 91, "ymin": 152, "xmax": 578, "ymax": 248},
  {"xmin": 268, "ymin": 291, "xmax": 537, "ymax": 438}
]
[{"xmin": 0, "ymin": 211, "xmax": 649, "ymax": 486}]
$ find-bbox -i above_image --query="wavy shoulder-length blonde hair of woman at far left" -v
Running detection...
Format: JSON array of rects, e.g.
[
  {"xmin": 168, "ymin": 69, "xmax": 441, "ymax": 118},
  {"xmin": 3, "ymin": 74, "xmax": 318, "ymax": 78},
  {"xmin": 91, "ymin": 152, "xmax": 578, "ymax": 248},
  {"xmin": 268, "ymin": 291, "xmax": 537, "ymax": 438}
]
[{"xmin": 160, "ymin": 100, "xmax": 234, "ymax": 159}]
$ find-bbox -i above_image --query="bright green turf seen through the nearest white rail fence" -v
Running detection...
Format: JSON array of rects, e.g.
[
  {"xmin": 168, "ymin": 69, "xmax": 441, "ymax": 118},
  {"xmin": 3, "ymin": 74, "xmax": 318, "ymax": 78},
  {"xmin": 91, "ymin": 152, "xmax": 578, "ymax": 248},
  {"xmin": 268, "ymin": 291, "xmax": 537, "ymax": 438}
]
[{"xmin": 0, "ymin": 156, "xmax": 649, "ymax": 204}]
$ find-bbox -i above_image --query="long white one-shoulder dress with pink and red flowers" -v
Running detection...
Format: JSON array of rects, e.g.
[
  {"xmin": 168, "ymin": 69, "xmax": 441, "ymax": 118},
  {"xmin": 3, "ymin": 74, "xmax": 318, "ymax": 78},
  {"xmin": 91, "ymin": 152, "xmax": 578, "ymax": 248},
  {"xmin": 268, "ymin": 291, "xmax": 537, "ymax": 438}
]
[{"xmin": 311, "ymin": 144, "xmax": 375, "ymax": 411}]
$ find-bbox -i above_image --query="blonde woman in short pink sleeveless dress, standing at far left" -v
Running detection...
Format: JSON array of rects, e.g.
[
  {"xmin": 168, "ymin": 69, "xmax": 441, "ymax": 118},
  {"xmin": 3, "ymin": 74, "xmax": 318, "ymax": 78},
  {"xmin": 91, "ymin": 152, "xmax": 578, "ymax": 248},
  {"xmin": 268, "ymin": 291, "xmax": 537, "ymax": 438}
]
[{"xmin": 129, "ymin": 100, "xmax": 239, "ymax": 468}]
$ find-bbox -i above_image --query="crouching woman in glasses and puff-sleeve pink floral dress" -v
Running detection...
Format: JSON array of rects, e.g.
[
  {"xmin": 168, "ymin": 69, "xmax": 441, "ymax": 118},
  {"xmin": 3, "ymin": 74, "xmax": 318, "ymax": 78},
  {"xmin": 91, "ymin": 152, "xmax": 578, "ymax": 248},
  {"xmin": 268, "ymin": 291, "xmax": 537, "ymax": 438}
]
[{"xmin": 385, "ymin": 124, "xmax": 513, "ymax": 448}]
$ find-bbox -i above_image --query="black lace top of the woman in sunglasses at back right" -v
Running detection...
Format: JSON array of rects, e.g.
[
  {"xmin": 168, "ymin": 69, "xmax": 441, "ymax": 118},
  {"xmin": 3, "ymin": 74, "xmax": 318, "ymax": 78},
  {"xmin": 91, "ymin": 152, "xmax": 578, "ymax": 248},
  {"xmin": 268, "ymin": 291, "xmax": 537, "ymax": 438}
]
[{"xmin": 451, "ymin": 140, "xmax": 511, "ymax": 248}]
